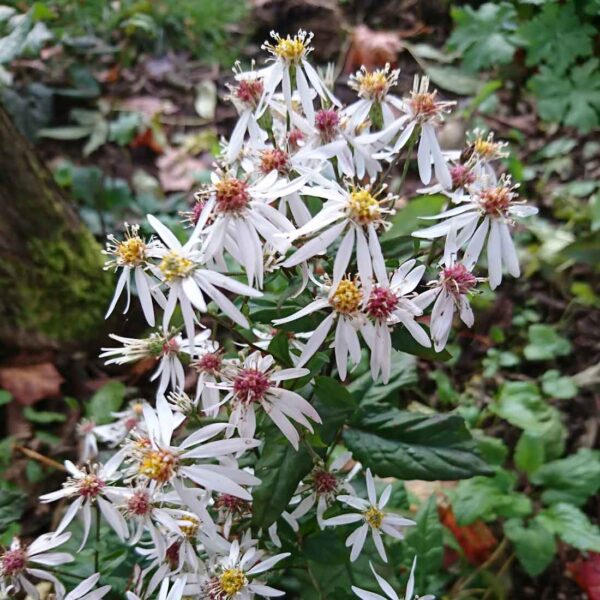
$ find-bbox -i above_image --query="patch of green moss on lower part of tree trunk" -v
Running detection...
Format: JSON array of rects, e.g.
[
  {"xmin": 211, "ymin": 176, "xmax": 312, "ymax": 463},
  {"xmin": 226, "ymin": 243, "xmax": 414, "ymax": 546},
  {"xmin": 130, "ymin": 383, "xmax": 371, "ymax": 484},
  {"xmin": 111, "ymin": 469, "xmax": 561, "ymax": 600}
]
[{"xmin": 11, "ymin": 228, "xmax": 112, "ymax": 342}]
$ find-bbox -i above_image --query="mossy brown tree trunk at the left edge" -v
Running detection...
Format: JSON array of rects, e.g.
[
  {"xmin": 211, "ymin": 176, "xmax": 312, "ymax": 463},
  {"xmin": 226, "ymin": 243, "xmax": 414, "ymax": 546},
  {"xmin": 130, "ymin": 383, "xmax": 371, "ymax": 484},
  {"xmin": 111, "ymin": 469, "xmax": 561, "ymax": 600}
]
[{"xmin": 0, "ymin": 107, "xmax": 112, "ymax": 349}]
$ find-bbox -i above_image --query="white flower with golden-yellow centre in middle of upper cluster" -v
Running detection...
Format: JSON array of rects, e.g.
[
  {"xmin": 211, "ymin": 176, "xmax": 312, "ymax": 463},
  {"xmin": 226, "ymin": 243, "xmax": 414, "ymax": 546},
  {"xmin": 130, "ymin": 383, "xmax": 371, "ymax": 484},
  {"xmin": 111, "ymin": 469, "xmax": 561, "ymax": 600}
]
[{"xmin": 282, "ymin": 183, "xmax": 395, "ymax": 294}]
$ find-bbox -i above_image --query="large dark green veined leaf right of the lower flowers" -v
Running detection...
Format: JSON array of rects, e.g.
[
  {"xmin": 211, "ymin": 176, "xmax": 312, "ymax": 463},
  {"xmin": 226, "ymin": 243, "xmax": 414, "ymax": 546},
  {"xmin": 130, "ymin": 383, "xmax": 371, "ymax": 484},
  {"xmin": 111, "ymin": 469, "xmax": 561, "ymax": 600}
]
[{"xmin": 344, "ymin": 406, "xmax": 490, "ymax": 481}]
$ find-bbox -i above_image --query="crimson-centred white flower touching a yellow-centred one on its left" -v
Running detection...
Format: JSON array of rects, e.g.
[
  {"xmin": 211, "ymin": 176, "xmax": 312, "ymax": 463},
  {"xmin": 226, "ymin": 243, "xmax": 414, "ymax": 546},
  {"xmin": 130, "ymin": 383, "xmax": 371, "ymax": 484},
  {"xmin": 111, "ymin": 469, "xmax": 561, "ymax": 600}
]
[{"xmin": 362, "ymin": 259, "xmax": 431, "ymax": 383}]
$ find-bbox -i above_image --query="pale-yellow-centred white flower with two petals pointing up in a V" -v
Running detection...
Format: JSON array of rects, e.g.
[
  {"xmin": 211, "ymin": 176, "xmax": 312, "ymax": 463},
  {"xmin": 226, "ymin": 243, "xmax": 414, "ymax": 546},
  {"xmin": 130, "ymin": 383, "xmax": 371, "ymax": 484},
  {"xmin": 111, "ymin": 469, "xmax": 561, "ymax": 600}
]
[{"xmin": 148, "ymin": 210, "xmax": 262, "ymax": 332}]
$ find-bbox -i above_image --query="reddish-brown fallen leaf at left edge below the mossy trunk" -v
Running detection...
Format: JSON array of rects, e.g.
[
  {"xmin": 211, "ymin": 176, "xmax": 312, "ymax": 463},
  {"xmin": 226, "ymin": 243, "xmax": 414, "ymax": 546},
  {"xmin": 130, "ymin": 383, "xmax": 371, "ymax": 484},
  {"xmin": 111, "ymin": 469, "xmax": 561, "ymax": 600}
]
[{"xmin": 0, "ymin": 362, "xmax": 64, "ymax": 405}]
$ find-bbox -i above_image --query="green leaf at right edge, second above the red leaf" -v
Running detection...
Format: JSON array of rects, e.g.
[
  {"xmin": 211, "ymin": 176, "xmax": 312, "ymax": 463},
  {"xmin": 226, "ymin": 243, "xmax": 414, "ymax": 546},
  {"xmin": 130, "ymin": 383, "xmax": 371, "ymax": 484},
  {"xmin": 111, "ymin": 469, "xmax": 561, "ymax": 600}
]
[{"xmin": 531, "ymin": 448, "xmax": 600, "ymax": 506}]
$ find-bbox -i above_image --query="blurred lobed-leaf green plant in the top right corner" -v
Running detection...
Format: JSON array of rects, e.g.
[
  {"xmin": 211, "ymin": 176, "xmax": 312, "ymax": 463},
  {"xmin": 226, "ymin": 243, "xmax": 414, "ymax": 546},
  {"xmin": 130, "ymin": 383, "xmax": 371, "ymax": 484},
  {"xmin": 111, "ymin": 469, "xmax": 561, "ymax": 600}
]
[{"xmin": 448, "ymin": 0, "xmax": 600, "ymax": 133}]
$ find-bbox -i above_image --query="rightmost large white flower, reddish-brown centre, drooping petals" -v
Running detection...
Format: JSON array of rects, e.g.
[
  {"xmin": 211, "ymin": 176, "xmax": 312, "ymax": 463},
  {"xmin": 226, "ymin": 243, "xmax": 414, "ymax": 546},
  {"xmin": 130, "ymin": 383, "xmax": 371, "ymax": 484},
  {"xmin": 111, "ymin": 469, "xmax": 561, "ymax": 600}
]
[{"xmin": 413, "ymin": 177, "xmax": 538, "ymax": 289}]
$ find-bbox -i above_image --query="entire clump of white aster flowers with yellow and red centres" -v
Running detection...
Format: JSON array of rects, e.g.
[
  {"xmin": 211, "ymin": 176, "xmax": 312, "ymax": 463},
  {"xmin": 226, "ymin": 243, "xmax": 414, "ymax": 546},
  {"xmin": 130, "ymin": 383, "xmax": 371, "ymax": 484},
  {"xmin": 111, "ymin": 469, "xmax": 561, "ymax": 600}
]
[{"xmin": 0, "ymin": 31, "xmax": 535, "ymax": 600}]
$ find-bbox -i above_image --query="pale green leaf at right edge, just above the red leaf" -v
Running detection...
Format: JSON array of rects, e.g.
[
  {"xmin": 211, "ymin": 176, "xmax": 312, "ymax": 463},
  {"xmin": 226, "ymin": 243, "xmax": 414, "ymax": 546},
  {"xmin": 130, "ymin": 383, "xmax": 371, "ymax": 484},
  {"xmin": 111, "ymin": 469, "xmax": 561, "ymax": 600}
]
[{"xmin": 537, "ymin": 503, "xmax": 600, "ymax": 552}]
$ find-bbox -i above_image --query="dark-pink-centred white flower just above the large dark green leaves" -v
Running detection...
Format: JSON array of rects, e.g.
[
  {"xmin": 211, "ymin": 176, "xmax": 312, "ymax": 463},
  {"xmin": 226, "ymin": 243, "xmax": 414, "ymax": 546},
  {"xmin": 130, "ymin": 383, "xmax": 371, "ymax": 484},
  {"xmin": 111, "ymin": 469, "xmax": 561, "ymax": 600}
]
[{"xmin": 214, "ymin": 351, "xmax": 321, "ymax": 450}]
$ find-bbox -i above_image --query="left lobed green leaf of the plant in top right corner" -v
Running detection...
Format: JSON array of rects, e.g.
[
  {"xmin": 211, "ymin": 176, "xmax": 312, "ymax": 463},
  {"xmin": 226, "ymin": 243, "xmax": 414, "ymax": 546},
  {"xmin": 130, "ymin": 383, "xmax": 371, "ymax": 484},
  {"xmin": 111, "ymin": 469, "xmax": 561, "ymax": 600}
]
[{"xmin": 448, "ymin": 2, "xmax": 517, "ymax": 71}]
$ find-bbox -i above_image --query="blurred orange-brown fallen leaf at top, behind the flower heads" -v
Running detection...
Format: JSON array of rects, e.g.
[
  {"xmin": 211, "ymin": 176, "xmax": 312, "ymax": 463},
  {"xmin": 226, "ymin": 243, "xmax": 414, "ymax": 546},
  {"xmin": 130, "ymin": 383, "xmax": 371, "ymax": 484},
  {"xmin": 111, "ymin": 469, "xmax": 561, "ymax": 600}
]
[{"xmin": 344, "ymin": 25, "xmax": 402, "ymax": 73}]
